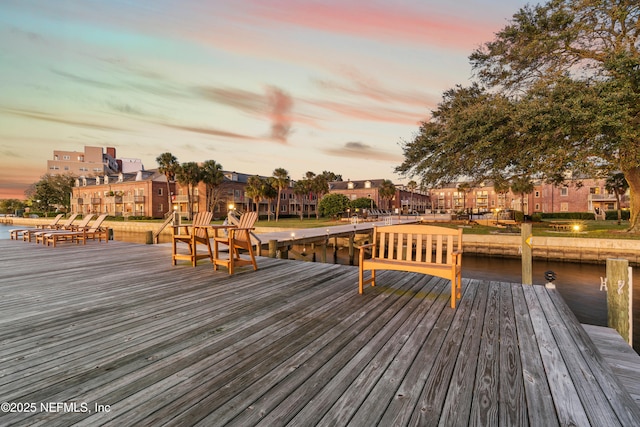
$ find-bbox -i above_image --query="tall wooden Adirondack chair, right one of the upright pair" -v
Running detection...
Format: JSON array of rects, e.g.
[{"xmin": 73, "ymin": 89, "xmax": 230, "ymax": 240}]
[{"xmin": 211, "ymin": 212, "xmax": 258, "ymax": 274}]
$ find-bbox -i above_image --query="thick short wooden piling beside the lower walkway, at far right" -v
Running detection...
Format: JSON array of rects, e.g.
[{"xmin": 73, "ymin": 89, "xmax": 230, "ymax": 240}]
[{"xmin": 607, "ymin": 258, "xmax": 633, "ymax": 345}]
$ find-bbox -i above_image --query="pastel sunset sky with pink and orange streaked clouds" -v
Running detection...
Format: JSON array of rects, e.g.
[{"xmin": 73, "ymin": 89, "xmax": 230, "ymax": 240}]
[{"xmin": 0, "ymin": 0, "xmax": 527, "ymax": 199}]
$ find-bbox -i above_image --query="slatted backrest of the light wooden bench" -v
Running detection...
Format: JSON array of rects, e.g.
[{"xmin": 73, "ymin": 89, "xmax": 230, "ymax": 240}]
[{"xmin": 371, "ymin": 224, "xmax": 462, "ymax": 264}]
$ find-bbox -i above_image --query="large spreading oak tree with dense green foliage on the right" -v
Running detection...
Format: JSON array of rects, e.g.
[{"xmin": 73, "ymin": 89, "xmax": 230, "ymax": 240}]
[{"xmin": 397, "ymin": 0, "xmax": 640, "ymax": 232}]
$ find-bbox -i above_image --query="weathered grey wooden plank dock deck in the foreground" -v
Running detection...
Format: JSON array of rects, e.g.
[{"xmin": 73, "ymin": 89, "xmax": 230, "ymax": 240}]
[{"xmin": 0, "ymin": 240, "xmax": 640, "ymax": 427}]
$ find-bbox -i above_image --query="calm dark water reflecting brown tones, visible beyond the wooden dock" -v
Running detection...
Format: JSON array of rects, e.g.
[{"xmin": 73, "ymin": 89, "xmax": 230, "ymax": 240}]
[{"xmin": 0, "ymin": 224, "xmax": 640, "ymax": 353}]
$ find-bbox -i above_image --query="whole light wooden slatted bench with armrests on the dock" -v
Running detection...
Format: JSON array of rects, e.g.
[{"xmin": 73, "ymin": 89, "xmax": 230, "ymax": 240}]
[{"xmin": 358, "ymin": 224, "xmax": 462, "ymax": 308}]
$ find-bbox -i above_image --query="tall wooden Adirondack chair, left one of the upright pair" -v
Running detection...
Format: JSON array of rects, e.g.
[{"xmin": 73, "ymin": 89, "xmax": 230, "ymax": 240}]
[{"xmin": 171, "ymin": 212, "xmax": 213, "ymax": 267}]
